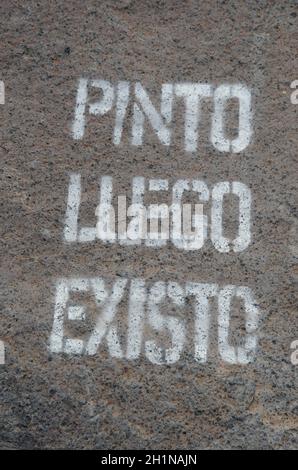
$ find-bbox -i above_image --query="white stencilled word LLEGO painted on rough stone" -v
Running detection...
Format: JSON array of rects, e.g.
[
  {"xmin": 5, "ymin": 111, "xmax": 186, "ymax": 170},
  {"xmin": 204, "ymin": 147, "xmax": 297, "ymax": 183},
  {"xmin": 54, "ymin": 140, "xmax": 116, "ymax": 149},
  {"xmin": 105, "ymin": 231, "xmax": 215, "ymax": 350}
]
[{"xmin": 64, "ymin": 174, "xmax": 251, "ymax": 253}]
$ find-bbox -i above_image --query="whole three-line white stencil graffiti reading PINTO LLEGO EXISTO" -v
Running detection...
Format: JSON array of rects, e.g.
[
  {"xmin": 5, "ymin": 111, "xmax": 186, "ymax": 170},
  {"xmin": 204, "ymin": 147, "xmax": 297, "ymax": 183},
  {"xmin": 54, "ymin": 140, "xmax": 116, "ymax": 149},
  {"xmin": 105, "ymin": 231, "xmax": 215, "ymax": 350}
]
[{"xmin": 58, "ymin": 78, "xmax": 259, "ymax": 365}]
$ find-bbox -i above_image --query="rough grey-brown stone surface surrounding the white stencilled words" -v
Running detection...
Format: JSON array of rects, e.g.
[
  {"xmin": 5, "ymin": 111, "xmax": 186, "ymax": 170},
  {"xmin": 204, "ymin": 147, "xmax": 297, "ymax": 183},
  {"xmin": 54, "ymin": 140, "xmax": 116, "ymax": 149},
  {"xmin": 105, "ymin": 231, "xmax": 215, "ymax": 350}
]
[{"xmin": 0, "ymin": 0, "xmax": 298, "ymax": 449}]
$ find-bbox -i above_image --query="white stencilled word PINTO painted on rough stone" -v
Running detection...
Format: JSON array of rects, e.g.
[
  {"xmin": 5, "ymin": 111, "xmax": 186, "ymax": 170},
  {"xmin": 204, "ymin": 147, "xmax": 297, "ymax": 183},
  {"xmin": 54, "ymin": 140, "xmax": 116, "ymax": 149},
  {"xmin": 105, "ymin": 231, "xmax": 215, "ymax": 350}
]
[{"xmin": 72, "ymin": 78, "xmax": 252, "ymax": 153}]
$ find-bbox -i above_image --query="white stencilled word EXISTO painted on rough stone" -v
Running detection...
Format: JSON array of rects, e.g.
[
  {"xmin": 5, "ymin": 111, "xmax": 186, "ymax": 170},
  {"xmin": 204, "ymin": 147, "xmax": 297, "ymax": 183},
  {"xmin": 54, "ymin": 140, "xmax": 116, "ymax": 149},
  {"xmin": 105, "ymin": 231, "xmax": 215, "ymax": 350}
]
[{"xmin": 50, "ymin": 277, "xmax": 259, "ymax": 365}]
